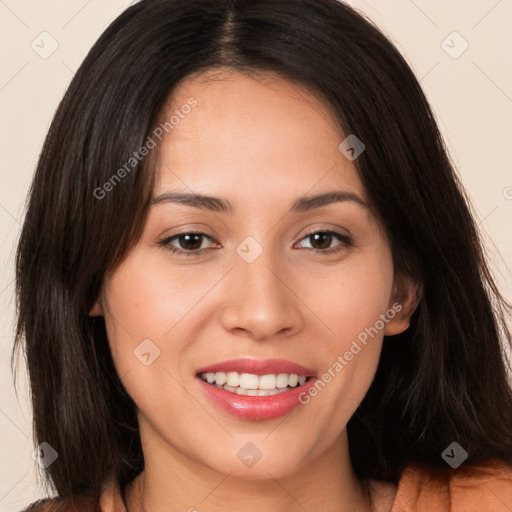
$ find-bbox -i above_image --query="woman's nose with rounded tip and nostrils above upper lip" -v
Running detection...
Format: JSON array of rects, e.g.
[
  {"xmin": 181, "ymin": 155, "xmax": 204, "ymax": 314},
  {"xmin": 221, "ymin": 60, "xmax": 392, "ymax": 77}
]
[{"xmin": 221, "ymin": 246, "xmax": 304, "ymax": 341}]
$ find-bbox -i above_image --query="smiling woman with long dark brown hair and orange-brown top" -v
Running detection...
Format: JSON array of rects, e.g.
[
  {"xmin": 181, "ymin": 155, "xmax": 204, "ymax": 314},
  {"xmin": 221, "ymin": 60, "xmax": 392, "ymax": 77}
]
[{"xmin": 17, "ymin": 0, "xmax": 512, "ymax": 512}]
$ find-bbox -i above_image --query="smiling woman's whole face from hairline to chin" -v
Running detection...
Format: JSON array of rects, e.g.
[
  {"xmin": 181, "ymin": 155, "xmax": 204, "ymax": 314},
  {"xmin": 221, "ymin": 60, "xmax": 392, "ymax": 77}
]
[{"xmin": 91, "ymin": 72, "xmax": 409, "ymax": 478}]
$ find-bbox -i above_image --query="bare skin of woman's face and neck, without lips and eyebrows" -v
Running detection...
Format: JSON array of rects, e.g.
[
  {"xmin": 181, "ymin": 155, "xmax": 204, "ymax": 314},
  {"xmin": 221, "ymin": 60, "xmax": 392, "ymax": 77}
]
[{"xmin": 91, "ymin": 70, "xmax": 416, "ymax": 512}]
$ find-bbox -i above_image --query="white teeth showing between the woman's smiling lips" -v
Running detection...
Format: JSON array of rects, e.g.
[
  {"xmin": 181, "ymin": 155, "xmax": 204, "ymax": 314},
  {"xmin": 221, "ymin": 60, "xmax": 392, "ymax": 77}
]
[{"xmin": 198, "ymin": 372, "xmax": 311, "ymax": 396}]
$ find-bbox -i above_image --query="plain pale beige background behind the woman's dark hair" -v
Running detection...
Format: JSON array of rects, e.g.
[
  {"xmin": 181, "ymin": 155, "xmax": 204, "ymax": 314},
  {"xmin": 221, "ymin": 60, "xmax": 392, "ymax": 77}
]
[{"xmin": 0, "ymin": 0, "xmax": 512, "ymax": 512}]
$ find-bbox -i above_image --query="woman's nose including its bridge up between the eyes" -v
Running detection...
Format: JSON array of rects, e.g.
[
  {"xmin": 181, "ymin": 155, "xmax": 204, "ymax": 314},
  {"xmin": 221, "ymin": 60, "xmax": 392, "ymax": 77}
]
[{"xmin": 223, "ymin": 237, "xmax": 301, "ymax": 339}]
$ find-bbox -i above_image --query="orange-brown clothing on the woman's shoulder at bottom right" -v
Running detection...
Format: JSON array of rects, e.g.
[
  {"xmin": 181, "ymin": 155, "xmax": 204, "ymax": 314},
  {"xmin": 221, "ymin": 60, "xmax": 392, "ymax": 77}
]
[{"xmin": 390, "ymin": 459, "xmax": 512, "ymax": 512}]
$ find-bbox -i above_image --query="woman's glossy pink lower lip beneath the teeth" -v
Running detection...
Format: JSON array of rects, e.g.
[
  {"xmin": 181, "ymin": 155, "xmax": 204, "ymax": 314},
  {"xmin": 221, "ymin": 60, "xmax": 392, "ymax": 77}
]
[{"xmin": 197, "ymin": 377, "xmax": 318, "ymax": 420}]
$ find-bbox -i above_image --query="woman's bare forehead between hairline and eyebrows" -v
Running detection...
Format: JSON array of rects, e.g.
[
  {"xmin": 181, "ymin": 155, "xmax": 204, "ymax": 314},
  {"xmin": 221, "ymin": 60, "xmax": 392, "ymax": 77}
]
[{"xmin": 151, "ymin": 71, "xmax": 365, "ymax": 205}]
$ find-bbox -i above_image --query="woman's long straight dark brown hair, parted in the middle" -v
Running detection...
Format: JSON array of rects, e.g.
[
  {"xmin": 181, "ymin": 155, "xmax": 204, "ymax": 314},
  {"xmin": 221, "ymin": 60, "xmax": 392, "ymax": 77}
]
[{"xmin": 13, "ymin": 0, "xmax": 512, "ymax": 504}]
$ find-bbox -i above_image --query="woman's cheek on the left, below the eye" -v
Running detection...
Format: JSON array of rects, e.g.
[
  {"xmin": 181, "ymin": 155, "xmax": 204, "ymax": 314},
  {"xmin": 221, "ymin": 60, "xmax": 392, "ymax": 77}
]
[{"xmin": 104, "ymin": 250, "xmax": 227, "ymax": 409}]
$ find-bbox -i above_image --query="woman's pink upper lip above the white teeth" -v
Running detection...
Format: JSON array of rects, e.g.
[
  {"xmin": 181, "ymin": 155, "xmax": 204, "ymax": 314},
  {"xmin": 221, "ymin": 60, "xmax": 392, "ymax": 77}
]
[{"xmin": 197, "ymin": 357, "xmax": 315, "ymax": 377}]
